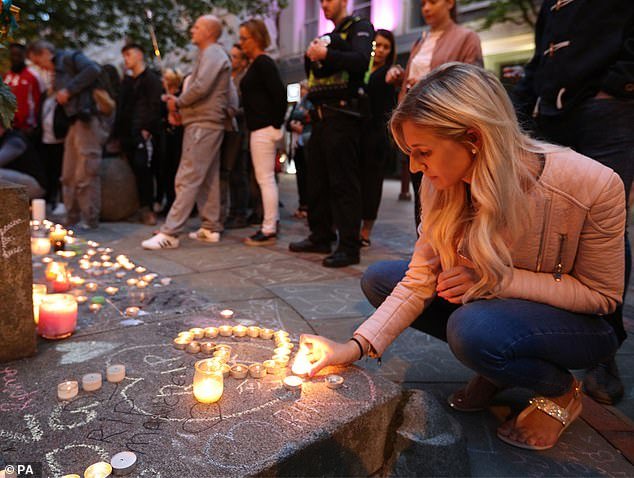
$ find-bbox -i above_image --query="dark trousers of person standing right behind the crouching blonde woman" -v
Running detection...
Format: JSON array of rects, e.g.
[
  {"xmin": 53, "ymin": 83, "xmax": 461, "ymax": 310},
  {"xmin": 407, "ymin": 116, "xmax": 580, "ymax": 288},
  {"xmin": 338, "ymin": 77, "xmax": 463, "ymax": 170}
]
[{"xmin": 537, "ymin": 98, "xmax": 634, "ymax": 343}]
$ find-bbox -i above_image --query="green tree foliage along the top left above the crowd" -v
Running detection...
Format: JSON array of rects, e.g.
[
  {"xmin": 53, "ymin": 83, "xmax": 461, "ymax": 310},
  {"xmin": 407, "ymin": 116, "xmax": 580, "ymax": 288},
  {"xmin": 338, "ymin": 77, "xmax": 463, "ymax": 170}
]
[{"xmin": 8, "ymin": 0, "xmax": 287, "ymax": 50}]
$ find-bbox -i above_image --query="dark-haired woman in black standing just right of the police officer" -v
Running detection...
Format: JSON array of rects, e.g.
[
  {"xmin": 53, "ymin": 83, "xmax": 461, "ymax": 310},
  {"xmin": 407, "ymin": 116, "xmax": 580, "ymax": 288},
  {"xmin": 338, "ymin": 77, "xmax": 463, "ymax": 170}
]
[{"xmin": 361, "ymin": 29, "xmax": 396, "ymax": 247}]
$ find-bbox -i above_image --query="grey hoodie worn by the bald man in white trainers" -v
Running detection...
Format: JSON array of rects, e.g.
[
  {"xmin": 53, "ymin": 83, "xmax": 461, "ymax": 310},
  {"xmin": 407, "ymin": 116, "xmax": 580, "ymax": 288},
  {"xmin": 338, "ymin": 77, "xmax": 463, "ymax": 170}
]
[{"xmin": 176, "ymin": 43, "xmax": 231, "ymax": 129}]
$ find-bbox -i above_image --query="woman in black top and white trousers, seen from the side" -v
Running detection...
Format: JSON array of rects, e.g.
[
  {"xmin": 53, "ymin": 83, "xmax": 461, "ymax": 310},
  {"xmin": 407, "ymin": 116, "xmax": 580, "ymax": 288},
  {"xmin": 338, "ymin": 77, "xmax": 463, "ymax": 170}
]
[{"xmin": 239, "ymin": 19, "xmax": 286, "ymax": 246}]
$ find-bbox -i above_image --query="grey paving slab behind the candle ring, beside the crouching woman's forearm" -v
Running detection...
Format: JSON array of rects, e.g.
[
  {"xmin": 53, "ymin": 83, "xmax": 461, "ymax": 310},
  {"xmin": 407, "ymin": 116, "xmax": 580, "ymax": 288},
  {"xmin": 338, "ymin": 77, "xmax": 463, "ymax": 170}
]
[{"xmin": 269, "ymin": 277, "xmax": 374, "ymax": 320}]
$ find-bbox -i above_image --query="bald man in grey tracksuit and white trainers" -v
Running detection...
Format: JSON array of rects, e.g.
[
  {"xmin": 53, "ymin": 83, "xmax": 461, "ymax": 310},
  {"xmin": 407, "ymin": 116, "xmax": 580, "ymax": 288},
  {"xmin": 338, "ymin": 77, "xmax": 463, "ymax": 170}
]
[{"xmin": 142, "ymin": 15, "xmax": 231, "ymax": 249}]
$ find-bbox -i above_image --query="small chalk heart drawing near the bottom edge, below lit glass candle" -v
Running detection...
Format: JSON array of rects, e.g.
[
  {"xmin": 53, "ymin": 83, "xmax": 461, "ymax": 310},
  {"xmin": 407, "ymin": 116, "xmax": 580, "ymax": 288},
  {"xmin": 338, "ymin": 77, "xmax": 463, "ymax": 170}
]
[{"xmin": 204, "ymin": 420, "xmax": 286, "ymax": 472}]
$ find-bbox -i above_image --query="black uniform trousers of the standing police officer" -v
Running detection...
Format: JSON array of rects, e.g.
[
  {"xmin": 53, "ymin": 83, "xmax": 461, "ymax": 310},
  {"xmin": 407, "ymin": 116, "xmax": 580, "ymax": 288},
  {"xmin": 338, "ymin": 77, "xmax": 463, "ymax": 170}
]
[{"xmin": 308, "ymin": 114, "xmax": 362, "ymax": 255}]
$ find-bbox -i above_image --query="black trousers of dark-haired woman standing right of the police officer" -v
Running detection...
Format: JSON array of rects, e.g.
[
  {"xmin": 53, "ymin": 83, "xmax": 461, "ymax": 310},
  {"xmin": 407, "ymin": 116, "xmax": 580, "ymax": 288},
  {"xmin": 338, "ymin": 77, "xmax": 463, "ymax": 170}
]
[{"xmin": 361, "ymin": 121, "xmax": 389, "ymax": 221}]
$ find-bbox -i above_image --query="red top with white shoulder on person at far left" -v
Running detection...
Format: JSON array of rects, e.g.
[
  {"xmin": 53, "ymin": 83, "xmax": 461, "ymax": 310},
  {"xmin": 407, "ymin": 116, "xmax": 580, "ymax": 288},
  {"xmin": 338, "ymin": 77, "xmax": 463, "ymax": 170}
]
[{"xmin": 4, "ymin": 68, "xmax": 41, "ymax": 130}]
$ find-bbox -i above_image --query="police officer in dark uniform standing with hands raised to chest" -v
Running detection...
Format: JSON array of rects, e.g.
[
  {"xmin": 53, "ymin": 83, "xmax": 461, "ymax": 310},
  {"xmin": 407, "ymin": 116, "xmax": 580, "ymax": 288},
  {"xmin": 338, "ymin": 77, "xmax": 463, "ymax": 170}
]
[{"xmin": 289, "ymin": 0, "xmax": 374, "ymax": 267}]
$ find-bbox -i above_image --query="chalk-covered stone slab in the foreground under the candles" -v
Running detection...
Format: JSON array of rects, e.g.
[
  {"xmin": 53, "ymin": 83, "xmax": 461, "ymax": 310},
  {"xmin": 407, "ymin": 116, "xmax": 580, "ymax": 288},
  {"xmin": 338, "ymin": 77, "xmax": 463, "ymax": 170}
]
[{"xmin": 0, "ymin": 320, "xmax": 401, "ymax": 478}]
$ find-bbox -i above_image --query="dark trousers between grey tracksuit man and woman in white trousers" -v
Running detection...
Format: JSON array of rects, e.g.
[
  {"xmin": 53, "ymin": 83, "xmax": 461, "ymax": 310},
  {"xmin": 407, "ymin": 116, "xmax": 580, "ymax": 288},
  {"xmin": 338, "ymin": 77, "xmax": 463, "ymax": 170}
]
[{"xmin": 220, "ymin": 131, "xmax": 249, "ymax": 220}]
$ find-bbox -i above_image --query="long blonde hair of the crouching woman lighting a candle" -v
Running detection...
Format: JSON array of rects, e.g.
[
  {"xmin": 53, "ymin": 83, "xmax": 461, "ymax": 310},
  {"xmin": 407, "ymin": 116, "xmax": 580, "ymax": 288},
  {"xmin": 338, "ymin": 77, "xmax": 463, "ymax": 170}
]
[{"xmin": 390, "ymin": 63, "xmax": 548, "ymax": 302}]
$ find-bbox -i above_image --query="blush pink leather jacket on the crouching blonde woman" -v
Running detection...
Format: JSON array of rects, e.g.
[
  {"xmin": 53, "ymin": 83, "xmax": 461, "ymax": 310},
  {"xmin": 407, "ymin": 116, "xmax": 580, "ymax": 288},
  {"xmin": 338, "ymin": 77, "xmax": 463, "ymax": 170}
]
[{"xmin": 355, "ymin": 148, "xmax": 625, "ymax": 356}]
